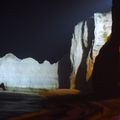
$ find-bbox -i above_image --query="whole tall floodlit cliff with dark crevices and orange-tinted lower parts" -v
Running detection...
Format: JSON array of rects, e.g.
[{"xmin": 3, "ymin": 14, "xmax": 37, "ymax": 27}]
[{"xmin": 70, "ymin": 12, "xmax": 112, "ymax": 89}]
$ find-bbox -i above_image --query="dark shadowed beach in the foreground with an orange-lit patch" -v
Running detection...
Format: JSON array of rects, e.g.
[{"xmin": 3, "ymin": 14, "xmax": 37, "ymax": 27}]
[{"xmin": 0, "ymin": 90, "xmax": 120, "ymax": 120}]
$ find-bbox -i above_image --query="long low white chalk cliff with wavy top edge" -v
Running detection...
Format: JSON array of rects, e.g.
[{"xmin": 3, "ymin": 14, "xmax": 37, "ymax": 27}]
[{"xmin": 0, "ymin": 53, "xmax": 58, "ymax": 89}]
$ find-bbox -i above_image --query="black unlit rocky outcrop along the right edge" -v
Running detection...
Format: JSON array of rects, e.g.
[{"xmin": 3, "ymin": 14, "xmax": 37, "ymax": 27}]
[{"xmin": 92, "ymin": 0, "xmax": 120, "ymax": 93}]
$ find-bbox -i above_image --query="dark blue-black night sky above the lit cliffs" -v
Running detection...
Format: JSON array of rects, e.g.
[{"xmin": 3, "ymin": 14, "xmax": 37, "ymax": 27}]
[{"xmin": 0, "ymin": 0, "xmax": 111, "ymax": 63}]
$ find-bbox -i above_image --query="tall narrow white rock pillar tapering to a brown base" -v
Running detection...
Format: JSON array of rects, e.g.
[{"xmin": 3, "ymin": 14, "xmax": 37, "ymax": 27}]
[{"xmin": 70, "ymin": 22, "xmax": 83, "ymax": 88}]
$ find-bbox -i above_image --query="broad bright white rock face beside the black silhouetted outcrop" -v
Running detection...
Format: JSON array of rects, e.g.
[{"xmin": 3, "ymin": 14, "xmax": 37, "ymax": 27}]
[{"xmin": 93, "ymin": 12, "xmax": 112, "ymax": 57}]
